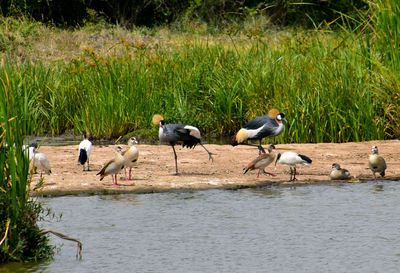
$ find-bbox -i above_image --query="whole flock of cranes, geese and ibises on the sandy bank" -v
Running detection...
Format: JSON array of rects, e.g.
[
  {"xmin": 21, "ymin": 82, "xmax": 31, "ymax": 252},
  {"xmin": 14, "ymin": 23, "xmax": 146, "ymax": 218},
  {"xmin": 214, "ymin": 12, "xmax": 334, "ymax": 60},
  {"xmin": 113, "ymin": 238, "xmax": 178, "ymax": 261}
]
[{"xmin": 24, "ymin": 109, "xmax": 387, "ymax": 187}]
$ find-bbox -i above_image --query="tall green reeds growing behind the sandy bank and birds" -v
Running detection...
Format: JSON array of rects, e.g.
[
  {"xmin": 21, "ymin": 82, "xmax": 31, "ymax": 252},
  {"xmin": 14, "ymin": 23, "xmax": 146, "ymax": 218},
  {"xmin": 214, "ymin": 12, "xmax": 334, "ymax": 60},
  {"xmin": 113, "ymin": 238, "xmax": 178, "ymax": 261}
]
[{"xmin": 2, "ymin": 8, "xmax": 400, "ymax": 143}]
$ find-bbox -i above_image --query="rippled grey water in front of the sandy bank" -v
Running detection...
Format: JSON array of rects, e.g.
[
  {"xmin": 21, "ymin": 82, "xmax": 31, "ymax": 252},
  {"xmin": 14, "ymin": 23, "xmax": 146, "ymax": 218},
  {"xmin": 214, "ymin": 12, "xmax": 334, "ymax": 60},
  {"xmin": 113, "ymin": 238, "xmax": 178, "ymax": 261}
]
[{"xmin": 3, "ymin": 182, "xmax": 400, "ymax": 273}]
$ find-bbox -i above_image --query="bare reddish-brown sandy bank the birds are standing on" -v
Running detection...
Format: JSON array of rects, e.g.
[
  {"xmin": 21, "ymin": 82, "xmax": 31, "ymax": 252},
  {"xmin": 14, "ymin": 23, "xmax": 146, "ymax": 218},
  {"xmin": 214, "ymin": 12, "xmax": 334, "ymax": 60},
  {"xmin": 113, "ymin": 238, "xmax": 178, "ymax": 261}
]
[{"xmin": 31, "ymin": 140, "xmax": 400, "ymax": 197}]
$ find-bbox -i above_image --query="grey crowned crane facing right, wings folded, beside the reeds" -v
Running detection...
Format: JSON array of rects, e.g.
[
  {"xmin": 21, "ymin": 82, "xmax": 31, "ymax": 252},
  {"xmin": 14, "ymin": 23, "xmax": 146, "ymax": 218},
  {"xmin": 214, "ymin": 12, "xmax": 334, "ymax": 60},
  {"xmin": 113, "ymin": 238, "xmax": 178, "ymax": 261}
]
[{"xmin": 231, "ymin": 109, "xmax": 287, "ymax": 154}]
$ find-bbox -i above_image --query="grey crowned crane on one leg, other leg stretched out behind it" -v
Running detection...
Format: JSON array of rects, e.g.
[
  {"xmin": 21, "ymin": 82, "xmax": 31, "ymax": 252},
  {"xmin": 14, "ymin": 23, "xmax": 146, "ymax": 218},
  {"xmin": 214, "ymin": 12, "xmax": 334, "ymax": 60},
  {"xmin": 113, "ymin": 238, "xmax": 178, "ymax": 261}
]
[{"xmin": 153, "ymin": 115, "xmax": 213, "ymax": 175}]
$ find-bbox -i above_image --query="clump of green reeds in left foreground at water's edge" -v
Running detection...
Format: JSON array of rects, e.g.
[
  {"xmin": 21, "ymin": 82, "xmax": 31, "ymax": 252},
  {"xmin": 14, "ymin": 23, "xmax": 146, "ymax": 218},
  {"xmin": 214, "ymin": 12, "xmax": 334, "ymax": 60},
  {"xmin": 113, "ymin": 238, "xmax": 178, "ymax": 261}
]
[{"xmin": 0, "ymin": 70, "xmax": 53, "ymax": 263}]
